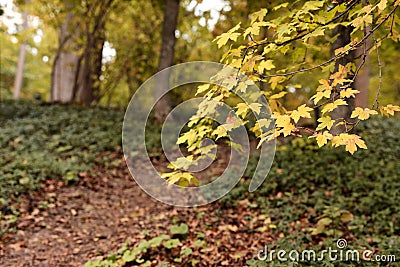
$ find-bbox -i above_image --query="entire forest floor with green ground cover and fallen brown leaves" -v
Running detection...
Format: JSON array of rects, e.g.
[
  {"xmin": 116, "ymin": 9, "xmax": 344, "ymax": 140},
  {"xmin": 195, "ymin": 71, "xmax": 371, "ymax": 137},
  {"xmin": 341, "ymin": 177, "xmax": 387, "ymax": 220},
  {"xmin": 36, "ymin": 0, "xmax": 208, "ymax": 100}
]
[{"xmin": 0, "ymin": 102, "xmax": 400, "ymax": 267}]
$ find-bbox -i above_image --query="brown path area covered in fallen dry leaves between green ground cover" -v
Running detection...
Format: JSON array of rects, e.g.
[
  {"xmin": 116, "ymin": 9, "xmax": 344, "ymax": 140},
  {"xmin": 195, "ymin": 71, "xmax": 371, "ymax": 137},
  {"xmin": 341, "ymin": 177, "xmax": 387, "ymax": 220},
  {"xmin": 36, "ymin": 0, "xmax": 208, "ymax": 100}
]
[{"xmin": 0, "ymin": 150, "xmax": 282, "ymax": 267}]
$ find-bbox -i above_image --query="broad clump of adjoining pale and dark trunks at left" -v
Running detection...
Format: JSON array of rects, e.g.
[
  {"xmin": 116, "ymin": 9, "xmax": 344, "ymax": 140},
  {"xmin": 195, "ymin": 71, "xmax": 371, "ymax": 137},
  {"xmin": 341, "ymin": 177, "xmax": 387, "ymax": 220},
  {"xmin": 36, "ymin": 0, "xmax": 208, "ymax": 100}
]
[{"xmin": 51, "ymin": 0, "xmax": 113, "ymax": 106}]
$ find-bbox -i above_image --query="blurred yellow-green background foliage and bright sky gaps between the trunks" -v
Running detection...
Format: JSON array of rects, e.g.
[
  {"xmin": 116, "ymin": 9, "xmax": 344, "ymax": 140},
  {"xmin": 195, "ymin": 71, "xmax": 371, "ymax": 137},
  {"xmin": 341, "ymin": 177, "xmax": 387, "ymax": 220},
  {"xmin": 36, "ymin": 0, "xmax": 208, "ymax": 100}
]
[{"xmin": 0, "ymin": 0, "xmax": 400, "ymax": 107}]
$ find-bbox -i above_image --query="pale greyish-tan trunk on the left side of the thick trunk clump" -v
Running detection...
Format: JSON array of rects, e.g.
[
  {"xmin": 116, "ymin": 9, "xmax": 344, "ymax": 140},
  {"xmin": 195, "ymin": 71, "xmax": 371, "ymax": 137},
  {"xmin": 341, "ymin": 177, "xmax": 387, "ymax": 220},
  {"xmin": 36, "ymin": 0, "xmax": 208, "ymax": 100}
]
[{"xmin": 50, "ymin": 9, "xmax": 79, "ymax": 104}]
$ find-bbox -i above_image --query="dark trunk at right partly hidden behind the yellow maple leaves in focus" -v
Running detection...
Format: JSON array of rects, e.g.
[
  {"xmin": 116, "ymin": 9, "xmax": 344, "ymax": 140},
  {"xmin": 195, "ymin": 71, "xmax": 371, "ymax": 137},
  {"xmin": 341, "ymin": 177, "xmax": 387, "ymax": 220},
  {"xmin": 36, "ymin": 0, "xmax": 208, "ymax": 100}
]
[{"xmin": 330, "ymin": 25, "xmax": 354, "ymax": 135}]
